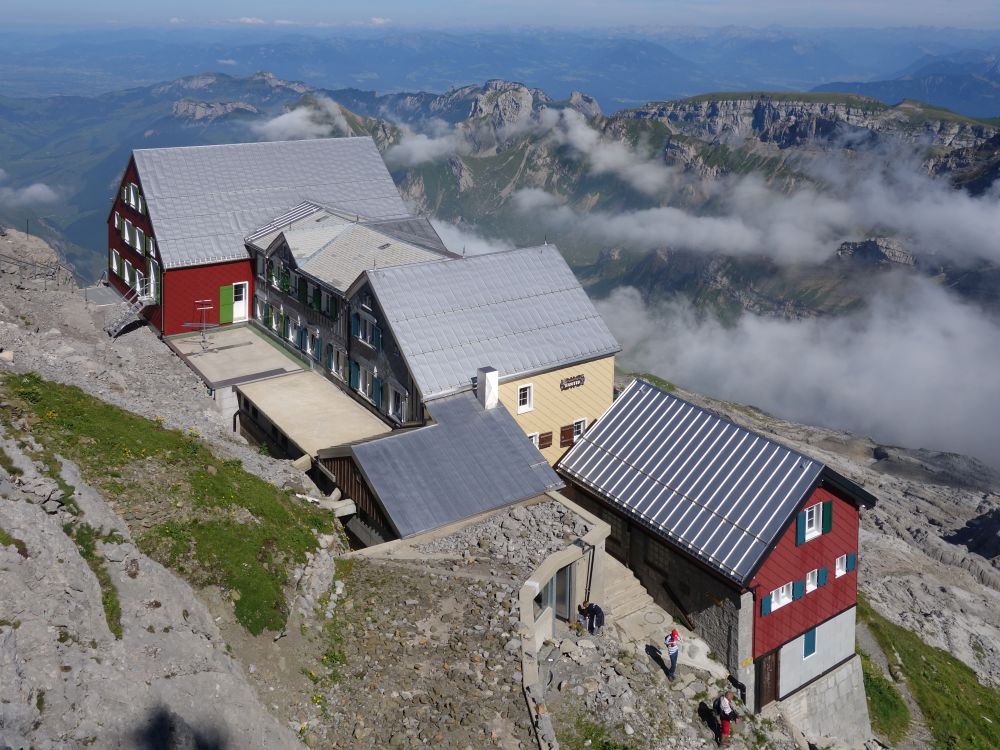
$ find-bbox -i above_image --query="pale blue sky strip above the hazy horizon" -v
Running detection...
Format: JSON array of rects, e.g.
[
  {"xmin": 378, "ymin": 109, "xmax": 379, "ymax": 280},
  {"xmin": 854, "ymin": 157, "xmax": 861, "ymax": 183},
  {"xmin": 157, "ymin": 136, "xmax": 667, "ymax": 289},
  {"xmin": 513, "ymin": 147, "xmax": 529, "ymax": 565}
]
[{"xmin": 0, "ymin": 0, "xmax": 1000, "ymax": 28}]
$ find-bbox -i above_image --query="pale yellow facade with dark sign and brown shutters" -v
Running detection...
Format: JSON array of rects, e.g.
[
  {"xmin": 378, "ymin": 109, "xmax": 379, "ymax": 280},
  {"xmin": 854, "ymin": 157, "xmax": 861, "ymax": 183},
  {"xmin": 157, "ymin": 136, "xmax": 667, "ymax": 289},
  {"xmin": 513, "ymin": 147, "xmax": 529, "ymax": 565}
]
[{"xmin": 500, "ymin": 355, "xmax": 615, "ymax": 465}]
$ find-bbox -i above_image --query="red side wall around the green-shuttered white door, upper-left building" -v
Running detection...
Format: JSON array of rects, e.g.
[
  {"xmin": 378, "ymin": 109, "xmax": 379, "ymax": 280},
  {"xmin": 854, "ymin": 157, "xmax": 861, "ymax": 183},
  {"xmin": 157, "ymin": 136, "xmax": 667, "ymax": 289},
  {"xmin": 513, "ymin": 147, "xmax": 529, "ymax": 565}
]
[{"xmin": 162, "ymin": 259, "xmax": 254, "ymax": 336}]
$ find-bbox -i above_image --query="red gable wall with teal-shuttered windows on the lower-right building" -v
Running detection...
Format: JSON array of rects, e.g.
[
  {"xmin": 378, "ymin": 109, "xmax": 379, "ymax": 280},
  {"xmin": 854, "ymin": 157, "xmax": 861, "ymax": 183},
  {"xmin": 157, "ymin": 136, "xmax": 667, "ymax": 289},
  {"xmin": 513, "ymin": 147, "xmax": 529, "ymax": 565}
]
[{"xmin": 750, "ymin": 488, "xmax": 858, "ymax": 659}]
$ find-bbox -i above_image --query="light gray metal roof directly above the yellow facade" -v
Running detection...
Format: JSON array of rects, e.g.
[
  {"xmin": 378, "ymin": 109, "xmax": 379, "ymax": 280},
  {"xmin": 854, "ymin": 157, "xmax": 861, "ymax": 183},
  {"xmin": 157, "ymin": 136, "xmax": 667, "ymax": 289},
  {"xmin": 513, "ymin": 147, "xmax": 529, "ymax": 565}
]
[{"xmin": 368, "ymin": 245, "xmax": 621, "ymax": 400}]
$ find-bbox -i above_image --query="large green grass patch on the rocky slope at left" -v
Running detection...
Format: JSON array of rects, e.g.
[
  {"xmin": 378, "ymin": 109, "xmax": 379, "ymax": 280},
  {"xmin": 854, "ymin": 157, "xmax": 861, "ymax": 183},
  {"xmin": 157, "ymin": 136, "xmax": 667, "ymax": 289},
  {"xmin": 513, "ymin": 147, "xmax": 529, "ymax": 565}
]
[{"xmin": 0, "ymin": 374, "xmax": 333, "ymax": 635}]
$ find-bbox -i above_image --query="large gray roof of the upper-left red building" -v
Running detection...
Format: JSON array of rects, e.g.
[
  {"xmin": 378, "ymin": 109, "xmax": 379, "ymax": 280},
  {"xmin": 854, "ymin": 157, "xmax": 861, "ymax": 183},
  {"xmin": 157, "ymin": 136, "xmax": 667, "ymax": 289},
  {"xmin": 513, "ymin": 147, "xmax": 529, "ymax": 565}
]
[{"xmin": 133, "ymin": 137, "xmax": 409, "ymax": 268}]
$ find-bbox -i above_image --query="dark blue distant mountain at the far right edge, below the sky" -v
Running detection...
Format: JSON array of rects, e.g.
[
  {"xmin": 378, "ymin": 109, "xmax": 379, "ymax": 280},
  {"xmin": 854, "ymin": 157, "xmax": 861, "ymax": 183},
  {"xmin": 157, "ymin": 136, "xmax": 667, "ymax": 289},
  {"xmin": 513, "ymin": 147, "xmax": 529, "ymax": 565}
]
[{"xmin": 813, "ymin": 48, "xmax": 1000, "ymax": 117}]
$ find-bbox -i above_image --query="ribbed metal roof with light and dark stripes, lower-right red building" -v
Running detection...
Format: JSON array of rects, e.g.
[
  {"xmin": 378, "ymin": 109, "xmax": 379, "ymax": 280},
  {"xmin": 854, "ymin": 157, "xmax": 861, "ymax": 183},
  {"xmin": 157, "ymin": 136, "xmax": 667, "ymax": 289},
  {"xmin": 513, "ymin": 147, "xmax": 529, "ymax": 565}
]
[{"xmin": 558, "ymin": 380, "xmax": 825, "ymax": 585}]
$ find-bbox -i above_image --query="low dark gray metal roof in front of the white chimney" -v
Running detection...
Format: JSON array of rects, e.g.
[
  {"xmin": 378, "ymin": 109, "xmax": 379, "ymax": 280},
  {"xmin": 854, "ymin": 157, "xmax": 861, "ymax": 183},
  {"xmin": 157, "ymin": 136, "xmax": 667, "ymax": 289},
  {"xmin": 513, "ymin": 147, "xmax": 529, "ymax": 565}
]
[{"xmin": 351, "ymin": 392, "xmax": 563, "ymax": 537}]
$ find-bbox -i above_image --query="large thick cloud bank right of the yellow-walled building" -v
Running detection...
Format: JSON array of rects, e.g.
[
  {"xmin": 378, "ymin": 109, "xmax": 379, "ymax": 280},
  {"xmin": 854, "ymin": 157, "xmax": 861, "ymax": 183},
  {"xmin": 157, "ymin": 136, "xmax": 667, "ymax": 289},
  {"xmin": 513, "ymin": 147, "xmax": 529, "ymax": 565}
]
[{"xmin": 597, "ymin": 277, "xmax": 1000, "ymax": 466}]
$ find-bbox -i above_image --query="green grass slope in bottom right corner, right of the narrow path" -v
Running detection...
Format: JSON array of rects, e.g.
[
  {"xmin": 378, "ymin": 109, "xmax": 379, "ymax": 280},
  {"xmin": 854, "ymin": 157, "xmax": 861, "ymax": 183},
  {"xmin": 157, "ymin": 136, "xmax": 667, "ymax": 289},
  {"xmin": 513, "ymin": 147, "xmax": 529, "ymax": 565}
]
[{"xmin": 858, "ymin": 597, "xmax": 1000, "ymax": 750}]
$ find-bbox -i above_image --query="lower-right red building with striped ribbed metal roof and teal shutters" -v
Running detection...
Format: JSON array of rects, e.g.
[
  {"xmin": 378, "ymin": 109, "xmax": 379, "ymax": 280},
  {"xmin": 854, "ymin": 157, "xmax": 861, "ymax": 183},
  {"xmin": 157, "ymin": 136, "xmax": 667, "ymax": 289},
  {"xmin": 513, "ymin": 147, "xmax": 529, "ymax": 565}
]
[{"xmin": 557, "ymin": 380, "xmax": 875, "ymax": 724}]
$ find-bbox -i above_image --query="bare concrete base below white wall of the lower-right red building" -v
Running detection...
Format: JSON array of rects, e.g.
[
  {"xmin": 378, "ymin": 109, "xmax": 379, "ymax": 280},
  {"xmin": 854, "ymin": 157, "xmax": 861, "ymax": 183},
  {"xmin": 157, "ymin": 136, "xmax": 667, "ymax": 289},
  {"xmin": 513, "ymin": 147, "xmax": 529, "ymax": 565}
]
[{"xmin": 780, "ymin": 655, "xmax": 872, "ymax": 750}]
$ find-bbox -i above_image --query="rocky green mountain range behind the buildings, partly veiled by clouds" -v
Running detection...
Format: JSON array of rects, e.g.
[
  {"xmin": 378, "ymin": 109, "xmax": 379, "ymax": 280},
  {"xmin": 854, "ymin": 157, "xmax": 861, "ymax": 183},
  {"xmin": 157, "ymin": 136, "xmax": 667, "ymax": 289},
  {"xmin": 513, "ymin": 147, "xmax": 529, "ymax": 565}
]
[{"xmin": 0, "ymin": 73, "xmax": 1000, "ymax": 318}]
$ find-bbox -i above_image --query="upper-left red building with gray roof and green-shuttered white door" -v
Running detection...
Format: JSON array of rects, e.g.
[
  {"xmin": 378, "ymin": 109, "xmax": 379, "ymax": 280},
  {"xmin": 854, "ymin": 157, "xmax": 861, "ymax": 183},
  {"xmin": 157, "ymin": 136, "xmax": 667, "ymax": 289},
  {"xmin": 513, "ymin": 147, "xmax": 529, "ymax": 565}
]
[{"xmin": 108, "ymin": 137, "xmax": 409, "ymax": 336}]
